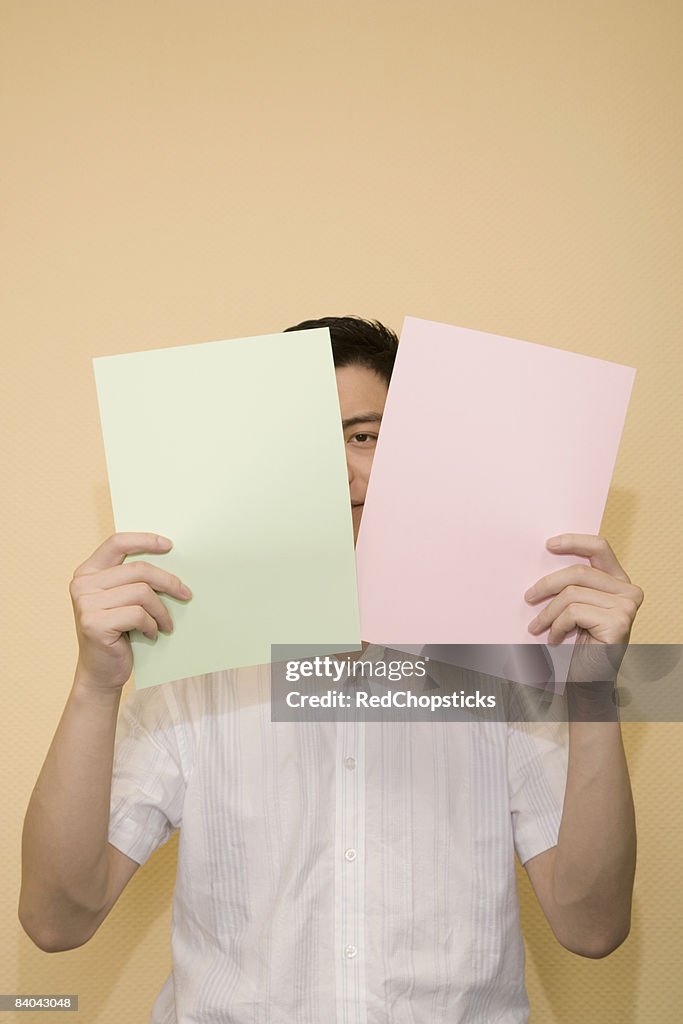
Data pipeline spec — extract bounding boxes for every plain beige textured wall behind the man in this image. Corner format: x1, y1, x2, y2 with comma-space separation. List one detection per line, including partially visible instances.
0, 0, 683, 1024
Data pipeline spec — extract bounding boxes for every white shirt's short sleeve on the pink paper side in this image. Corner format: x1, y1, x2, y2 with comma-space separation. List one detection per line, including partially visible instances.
508, 721, 569, 864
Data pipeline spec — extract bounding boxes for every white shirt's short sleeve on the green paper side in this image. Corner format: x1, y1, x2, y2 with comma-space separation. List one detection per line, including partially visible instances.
109, 685, 185, 864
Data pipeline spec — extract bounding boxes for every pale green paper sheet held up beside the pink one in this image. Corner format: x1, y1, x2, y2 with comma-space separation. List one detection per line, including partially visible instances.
93, 328, 360, 689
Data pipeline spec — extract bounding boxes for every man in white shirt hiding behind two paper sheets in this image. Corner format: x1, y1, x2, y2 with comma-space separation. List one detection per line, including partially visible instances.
19, 317, 643, 1024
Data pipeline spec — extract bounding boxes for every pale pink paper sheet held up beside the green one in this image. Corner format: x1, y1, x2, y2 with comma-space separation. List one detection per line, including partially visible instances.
356, 316, 636, 682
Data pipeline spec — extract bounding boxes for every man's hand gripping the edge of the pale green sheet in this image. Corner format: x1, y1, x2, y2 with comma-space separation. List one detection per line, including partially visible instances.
69, 534, 191, 690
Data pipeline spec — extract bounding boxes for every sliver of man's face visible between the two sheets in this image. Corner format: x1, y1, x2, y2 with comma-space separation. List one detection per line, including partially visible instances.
335, 365, 388, 543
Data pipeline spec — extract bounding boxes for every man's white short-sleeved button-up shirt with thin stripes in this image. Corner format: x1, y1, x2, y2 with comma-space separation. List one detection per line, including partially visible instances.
109, 647, 568, 1024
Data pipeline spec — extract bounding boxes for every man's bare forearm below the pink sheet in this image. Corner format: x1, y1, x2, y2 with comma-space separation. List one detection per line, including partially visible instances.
553, 721, 636, 948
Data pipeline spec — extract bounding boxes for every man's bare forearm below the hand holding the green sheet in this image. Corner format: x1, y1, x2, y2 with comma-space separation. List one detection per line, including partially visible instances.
19, 670, 121, 944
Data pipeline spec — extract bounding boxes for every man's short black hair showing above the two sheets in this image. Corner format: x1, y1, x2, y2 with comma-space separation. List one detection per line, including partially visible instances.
285, 316, 398, 386
